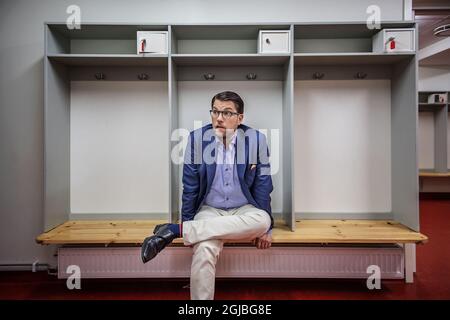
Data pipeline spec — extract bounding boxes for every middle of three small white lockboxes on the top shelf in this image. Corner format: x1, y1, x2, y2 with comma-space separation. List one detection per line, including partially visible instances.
258, 30, 291, 53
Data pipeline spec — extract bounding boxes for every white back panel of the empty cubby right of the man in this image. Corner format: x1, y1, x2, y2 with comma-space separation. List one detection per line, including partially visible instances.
294, 80, 391, 213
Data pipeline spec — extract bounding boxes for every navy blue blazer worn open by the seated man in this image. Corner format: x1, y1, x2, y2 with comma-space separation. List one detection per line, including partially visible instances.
182, 124, 273, 229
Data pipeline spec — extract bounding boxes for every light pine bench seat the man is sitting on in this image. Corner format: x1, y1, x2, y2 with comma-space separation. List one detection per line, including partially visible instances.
36, 220, 428, 245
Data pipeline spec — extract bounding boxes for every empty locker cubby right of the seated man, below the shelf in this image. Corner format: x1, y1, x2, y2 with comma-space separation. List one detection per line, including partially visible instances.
293, 45, 419, 228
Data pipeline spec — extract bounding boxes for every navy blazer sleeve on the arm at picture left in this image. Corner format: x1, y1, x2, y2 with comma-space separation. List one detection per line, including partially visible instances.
181, 134, 200, 221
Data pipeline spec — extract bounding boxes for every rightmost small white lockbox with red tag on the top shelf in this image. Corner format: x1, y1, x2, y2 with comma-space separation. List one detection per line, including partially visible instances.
372, 28, 416, 53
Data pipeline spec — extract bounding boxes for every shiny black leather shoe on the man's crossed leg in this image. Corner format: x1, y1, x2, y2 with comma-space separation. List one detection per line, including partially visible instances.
141, 223, 176, 263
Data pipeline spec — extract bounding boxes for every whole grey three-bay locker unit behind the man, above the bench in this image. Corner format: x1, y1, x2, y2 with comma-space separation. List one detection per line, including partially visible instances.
44, 22, 419, 231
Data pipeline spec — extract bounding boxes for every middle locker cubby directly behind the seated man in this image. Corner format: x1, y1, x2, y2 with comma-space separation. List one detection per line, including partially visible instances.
171, 48, 293, 225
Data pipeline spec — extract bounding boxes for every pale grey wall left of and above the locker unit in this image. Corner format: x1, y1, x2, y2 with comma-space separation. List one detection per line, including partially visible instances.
0, 0, 403, 264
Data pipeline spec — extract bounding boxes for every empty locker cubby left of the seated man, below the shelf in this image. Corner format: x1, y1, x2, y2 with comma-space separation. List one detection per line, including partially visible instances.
44, 25, 170, 228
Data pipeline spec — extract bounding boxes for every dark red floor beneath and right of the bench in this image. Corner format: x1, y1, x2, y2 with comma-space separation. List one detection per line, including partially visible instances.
0, 199, 450, 300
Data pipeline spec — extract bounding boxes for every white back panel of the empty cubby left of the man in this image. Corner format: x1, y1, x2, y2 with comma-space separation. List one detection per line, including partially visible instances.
70, 81, 169, 213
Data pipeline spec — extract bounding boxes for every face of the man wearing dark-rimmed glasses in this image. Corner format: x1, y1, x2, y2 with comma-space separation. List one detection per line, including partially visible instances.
211, 99, 244, 137
